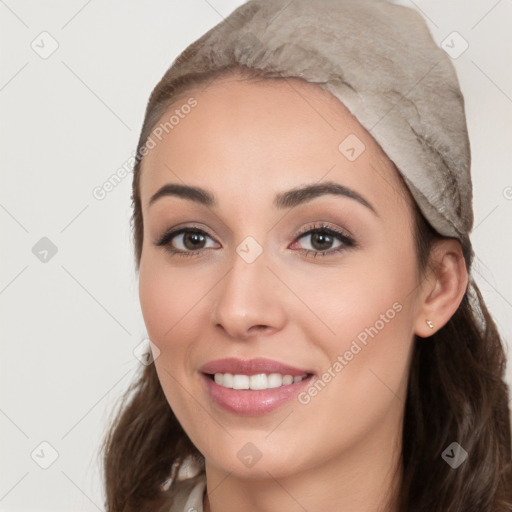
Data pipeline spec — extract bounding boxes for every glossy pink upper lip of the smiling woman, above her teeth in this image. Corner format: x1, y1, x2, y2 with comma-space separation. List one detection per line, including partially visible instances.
200, 357, 313, 377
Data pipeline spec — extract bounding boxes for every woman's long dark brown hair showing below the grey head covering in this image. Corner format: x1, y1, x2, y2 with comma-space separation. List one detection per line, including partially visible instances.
101, 65, 512, 512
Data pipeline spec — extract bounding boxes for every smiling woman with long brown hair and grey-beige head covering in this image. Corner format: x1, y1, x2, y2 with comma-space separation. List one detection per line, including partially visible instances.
100, 0, 512, 512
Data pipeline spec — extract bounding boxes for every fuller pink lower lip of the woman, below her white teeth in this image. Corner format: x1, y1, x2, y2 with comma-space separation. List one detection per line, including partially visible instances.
202, 373, 313, 416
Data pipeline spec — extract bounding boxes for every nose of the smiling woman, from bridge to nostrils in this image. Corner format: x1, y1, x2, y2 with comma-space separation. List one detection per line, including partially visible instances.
212, 247, 286, 341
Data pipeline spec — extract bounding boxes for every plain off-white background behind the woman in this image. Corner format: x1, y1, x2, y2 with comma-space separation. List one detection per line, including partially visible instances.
0, 0, 512, 512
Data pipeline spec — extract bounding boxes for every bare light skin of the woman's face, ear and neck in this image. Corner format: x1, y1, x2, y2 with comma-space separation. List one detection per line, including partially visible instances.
139, 75, 467, 512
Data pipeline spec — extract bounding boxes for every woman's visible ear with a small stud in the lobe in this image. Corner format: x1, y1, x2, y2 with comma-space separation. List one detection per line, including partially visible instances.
414, 238, 469, 338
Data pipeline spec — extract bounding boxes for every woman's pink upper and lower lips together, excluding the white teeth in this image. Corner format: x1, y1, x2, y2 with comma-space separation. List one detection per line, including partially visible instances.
200, 358, 312, 416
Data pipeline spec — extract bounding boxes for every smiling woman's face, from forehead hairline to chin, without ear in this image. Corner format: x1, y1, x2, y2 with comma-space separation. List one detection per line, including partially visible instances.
139, 76, 426, 478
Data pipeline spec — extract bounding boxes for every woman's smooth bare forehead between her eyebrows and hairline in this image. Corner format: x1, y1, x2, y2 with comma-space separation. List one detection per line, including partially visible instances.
140, 75, 407, 210
